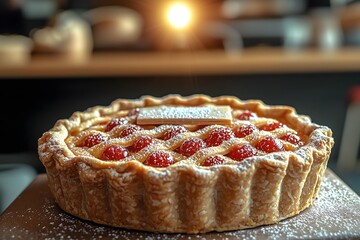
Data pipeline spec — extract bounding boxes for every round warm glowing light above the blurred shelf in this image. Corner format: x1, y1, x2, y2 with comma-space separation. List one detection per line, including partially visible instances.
167, 3, 191, 28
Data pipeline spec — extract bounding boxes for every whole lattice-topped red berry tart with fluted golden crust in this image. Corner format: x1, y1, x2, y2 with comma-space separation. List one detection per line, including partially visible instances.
38, 95, 334, 233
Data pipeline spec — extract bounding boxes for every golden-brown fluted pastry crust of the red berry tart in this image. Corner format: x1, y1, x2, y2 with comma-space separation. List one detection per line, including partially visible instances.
38, 95, 333, 233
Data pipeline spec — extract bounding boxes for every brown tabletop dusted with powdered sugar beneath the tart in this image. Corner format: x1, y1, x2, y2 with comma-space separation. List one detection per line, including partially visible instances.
0, 170, 360, 240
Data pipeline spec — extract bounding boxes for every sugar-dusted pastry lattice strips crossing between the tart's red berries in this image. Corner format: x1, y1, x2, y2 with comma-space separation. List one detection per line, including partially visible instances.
67, 111, 297, 167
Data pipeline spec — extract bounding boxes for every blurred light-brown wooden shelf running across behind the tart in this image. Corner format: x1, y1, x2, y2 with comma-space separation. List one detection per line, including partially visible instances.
0, 47, 360, 78
